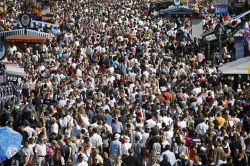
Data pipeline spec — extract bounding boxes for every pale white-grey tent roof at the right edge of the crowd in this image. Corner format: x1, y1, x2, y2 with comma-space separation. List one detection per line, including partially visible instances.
219, 57, 250, 74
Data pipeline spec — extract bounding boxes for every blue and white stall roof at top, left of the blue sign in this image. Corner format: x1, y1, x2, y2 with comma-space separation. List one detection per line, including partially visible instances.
161, 6, 193, 15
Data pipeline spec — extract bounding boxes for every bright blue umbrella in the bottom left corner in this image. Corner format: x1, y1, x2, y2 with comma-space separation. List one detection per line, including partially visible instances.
0, 126, 23, 161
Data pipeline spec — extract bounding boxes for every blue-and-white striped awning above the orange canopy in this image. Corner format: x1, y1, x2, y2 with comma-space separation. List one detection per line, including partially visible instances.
0, 29, 51, 38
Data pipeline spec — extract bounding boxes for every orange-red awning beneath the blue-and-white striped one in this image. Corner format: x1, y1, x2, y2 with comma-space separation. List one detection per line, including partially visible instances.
6, 35, 46, 43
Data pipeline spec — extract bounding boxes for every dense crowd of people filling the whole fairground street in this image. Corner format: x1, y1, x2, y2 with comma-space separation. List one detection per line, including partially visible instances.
0, 0, 250, 166
